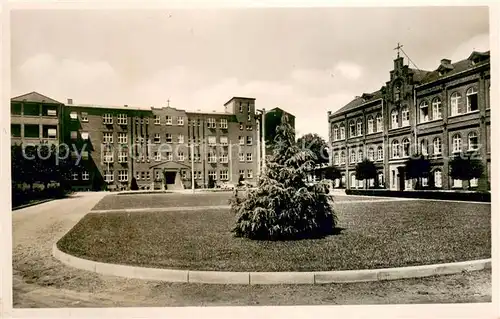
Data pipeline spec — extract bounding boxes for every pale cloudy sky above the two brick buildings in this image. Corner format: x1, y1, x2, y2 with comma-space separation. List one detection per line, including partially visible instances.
11, 7, 489, 139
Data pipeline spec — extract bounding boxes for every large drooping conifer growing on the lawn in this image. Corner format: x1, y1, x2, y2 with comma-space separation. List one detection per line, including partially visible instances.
231, 116, 337, 240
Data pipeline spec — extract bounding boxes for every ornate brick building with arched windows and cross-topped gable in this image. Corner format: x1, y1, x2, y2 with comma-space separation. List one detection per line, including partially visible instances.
328, 51, 491, 190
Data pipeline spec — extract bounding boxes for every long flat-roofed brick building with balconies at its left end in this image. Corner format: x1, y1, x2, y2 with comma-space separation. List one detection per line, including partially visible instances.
11, 92, 259, 190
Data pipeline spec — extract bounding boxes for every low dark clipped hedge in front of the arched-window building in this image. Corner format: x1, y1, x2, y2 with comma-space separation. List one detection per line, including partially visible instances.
345, 189, 491, 202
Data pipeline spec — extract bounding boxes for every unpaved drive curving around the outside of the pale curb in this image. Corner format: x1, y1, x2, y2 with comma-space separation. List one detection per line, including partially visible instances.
12, 193, 491, 308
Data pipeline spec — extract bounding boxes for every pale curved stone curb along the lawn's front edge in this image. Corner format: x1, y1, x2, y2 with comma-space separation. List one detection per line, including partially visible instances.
52, 243, 491, 285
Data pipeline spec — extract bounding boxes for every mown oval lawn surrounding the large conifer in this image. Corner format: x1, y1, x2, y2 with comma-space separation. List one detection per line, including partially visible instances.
58, 200, 491, 271
